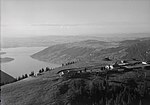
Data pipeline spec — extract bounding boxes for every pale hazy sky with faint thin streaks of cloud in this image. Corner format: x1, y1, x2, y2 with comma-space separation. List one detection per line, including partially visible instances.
1, 0, 150, 37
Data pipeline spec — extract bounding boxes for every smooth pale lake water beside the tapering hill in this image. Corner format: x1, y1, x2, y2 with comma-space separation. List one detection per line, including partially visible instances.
1, 47, 60, 77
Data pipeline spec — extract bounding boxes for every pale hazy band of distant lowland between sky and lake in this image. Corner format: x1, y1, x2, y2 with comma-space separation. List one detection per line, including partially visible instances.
1, 33, 150, 48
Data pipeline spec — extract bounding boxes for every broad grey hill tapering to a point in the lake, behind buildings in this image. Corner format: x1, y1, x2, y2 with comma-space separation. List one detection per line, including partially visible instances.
31, 38, 150, 64
